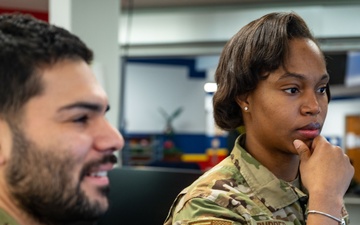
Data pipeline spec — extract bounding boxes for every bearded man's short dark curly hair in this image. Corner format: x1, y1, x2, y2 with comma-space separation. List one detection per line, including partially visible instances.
0, 14, 93, 119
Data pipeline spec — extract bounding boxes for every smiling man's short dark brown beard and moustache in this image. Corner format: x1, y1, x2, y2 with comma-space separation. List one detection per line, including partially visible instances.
5, 125, 111, 224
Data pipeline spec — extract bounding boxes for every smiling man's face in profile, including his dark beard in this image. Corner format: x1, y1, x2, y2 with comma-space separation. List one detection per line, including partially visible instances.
5, 60, 124, 224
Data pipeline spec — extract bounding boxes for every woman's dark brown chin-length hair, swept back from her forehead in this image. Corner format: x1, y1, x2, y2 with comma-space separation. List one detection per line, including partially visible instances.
213, 13, 330, 130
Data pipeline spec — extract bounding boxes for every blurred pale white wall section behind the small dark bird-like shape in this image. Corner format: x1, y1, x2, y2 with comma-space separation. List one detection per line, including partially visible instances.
125, 63, 206, 134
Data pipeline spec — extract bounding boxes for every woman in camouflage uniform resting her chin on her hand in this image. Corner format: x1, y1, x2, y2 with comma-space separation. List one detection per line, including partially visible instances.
165, 13, 354, 225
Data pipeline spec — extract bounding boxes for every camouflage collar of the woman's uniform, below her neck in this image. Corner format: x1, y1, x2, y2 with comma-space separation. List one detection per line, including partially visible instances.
231, 134, 307, 212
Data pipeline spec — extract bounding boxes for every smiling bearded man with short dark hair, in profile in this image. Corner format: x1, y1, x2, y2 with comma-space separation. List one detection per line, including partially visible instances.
0, 14, 124, 225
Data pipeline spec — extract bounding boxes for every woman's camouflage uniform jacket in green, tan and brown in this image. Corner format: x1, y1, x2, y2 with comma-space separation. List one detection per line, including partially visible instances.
164, 135, 348, 225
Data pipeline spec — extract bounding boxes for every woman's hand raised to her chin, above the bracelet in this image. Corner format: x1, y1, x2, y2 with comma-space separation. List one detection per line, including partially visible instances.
293, 136, 354, 216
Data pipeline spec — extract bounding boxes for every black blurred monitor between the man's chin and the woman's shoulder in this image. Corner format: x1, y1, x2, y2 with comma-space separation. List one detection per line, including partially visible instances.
97, 167, 202, 225
